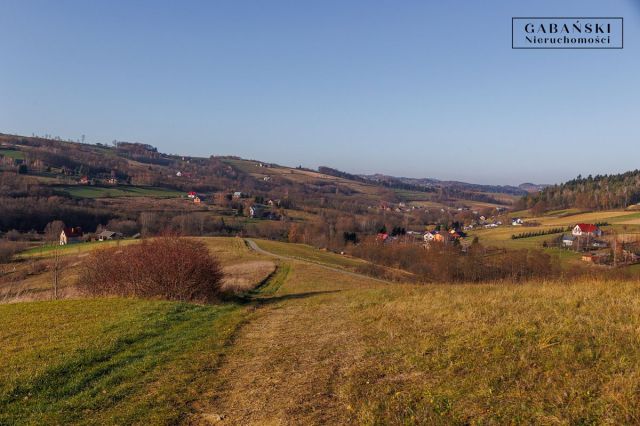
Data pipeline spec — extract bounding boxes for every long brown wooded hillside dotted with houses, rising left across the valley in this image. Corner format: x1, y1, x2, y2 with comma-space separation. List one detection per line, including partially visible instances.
0, 135, 518, 249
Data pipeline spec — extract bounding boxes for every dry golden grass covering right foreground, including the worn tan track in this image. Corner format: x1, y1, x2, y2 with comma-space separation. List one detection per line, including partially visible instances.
195, 248, 640, 424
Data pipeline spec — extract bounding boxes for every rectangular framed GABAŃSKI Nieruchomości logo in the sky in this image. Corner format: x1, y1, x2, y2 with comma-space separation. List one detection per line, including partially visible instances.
511, 18, 624, 49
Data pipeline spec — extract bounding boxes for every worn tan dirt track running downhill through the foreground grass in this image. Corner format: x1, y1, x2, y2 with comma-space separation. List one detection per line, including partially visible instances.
196, 258, 376, 425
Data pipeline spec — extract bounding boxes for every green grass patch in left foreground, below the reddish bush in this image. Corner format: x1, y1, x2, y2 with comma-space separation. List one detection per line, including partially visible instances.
0, 299, 247, 424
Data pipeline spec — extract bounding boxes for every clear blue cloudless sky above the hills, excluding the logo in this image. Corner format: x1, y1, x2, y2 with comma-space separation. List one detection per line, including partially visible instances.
0, 0, 640, 184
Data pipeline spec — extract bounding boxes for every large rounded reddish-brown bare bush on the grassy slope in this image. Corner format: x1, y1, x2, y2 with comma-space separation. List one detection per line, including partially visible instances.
79, 237, 223, 303
